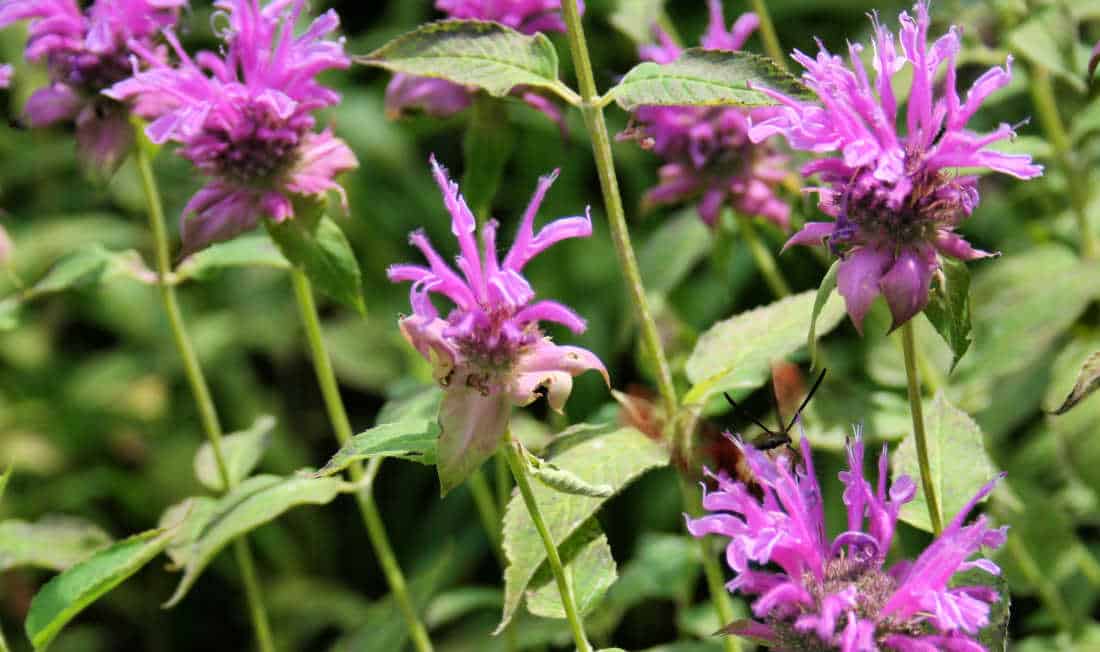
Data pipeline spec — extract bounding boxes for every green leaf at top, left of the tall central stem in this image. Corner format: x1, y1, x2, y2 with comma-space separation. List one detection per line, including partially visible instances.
354, 20, 575, 103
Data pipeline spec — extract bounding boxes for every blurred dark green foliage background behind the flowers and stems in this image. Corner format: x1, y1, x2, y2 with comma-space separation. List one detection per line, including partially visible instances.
0, 0, 1100, 652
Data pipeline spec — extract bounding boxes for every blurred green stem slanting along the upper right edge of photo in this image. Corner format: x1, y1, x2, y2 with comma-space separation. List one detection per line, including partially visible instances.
1031, 65, 1100, 261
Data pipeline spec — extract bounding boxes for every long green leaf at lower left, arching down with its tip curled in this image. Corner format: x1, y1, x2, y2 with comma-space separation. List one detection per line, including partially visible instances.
164, 475, 351, 607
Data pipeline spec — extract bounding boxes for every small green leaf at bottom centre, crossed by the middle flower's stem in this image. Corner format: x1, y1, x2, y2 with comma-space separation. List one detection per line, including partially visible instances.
527, 518, 617, 618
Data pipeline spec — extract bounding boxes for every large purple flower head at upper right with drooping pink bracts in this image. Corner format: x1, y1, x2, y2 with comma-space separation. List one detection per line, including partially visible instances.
749, 1, 1043, 329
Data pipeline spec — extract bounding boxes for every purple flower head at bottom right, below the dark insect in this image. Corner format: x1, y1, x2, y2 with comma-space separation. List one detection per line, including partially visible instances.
688, 429, 1007, 652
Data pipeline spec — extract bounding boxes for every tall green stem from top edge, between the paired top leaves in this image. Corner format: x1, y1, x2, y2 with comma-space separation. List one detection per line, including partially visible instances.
561, 0, 679, 421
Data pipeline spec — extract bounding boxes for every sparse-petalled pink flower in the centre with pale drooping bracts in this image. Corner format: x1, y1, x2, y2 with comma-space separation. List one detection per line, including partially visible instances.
388, 158, 608, 491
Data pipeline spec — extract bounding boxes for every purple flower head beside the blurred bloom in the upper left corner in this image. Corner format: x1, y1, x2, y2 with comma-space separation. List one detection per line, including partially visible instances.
107, 0, 358, 252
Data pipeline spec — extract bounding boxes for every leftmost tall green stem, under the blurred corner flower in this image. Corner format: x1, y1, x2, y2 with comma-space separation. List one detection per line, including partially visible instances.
134, 131, 275, 652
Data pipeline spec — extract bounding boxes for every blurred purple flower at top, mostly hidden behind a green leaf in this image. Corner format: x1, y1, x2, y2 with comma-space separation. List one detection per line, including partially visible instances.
386, 0, 584, 122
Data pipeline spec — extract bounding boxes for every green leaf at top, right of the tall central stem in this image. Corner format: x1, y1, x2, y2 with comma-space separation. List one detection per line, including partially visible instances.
604, 47, 814, 111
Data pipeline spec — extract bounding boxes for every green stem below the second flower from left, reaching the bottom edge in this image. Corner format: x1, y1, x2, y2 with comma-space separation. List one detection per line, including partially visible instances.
290, 267, 432, 652
